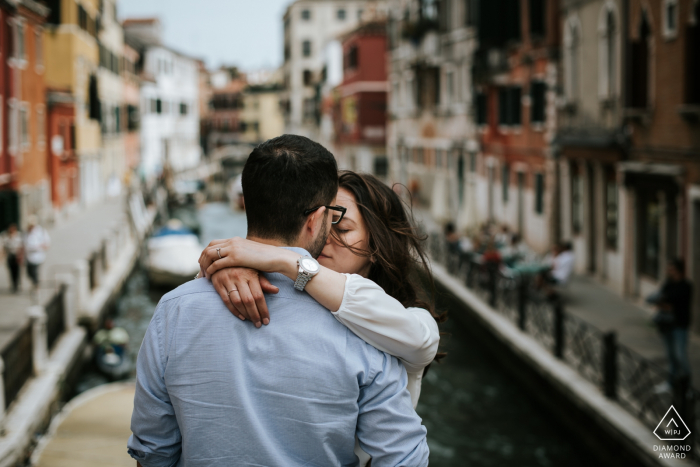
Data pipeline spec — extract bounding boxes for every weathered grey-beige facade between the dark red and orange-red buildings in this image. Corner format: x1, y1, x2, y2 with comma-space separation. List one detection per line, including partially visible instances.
387, 0, 478, 228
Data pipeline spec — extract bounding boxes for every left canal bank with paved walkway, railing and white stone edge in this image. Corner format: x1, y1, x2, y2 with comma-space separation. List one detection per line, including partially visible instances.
0, 194, 156, 466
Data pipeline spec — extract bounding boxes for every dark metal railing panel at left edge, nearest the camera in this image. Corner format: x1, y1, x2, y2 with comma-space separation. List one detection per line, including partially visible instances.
2, 322, 34, 408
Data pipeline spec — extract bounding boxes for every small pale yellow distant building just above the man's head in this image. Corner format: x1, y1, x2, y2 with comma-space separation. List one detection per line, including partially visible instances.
240, 84, 284, 143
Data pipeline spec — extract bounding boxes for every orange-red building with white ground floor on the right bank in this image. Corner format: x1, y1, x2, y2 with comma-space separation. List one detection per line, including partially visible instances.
474, 0, 561, 251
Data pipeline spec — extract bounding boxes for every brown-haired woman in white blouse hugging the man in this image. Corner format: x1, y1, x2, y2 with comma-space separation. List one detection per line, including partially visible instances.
200, 172, 443, 458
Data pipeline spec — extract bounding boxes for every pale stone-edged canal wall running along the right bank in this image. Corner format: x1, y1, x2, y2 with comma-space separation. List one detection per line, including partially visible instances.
433, 262, 697, 467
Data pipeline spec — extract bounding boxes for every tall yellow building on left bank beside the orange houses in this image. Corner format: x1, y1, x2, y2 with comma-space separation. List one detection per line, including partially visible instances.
44, 0, 105, 205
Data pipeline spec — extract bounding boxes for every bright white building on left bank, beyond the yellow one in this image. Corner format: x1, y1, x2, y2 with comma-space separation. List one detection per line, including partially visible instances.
124, 19, 201, 181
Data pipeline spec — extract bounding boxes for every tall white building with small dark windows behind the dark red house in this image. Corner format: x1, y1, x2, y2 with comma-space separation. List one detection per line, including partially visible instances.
282, 0, 386, 139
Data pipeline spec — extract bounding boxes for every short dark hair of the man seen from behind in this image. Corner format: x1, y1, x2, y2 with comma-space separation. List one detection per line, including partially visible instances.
242, 135, 338, 243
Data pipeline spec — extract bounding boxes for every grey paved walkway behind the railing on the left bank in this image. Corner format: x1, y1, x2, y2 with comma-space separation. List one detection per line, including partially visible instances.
0, 197, 126, 349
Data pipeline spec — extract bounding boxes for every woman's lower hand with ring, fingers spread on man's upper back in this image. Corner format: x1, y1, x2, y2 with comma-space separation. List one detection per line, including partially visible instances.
211, 266, 279, 328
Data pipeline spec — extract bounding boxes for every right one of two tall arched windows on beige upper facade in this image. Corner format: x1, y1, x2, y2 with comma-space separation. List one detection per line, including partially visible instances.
598, 3, 619, 100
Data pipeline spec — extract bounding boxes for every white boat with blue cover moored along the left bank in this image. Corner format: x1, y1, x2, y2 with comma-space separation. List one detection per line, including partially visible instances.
147, 219, 204, 287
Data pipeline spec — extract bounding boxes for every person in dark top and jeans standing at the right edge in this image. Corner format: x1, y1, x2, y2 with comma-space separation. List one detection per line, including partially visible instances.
655, 258, 693, 387
